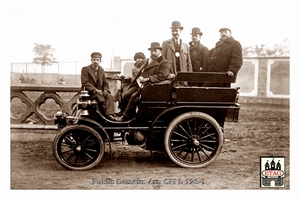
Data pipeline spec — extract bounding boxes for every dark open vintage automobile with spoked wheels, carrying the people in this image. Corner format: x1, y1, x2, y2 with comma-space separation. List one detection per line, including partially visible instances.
53, 72, 240, 170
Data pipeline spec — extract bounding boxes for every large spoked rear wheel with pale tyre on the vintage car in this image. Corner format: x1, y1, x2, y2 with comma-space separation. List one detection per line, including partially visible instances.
164, 112, 223, 168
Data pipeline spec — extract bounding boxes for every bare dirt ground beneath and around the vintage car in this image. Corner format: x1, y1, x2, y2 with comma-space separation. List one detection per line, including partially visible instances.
10, 104, 290, 191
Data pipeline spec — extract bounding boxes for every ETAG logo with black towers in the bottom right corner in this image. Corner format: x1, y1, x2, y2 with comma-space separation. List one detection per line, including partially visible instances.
260, 156, 285, 187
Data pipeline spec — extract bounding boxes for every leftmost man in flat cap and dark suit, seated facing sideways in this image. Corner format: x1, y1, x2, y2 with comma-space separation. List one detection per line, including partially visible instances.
81, 52, 116, 121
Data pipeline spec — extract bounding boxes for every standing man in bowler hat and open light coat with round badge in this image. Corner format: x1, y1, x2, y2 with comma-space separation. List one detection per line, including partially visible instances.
162, 21, 192, 84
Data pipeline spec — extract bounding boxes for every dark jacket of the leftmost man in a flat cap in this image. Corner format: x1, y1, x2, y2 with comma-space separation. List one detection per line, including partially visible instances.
81, 64, 110, 101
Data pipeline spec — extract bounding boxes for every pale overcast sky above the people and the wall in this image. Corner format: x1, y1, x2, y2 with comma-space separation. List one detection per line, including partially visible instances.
10, 0, 292, 65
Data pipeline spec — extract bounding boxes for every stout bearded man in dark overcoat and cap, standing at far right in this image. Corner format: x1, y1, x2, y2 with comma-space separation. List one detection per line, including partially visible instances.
203, 28, 243, 87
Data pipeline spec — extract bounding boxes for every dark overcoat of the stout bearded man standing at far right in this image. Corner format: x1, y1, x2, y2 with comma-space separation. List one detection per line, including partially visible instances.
208, 37, 243, 75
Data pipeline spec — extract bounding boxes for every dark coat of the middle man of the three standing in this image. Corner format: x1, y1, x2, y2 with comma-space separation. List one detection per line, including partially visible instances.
189, 41, 210, 72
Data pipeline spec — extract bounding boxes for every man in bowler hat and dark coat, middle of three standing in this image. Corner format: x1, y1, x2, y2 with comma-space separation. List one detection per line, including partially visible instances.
189, 27, 210, 86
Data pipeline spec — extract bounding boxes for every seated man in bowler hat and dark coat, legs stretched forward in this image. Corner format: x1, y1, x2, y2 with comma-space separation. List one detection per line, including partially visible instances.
118, 42, 171, 121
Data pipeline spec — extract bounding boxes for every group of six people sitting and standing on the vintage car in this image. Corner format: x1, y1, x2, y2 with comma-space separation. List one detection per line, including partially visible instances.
81, 21, 243, 121
